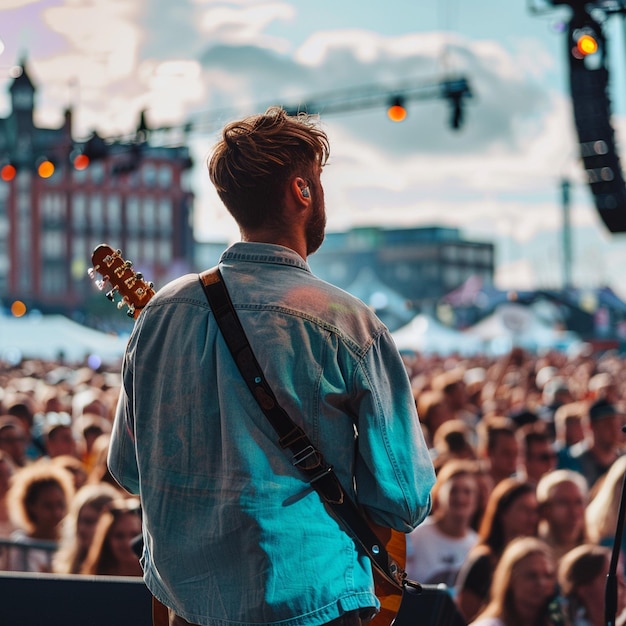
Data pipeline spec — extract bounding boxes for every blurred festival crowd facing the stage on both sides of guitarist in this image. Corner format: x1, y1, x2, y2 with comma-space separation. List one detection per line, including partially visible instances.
0, 342, 626, 626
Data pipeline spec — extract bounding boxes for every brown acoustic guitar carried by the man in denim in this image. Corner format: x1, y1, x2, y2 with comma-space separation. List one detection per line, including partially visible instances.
88, 243, 406, 626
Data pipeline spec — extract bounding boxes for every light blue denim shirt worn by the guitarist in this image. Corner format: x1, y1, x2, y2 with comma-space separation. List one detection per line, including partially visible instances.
109, 243, 434, 626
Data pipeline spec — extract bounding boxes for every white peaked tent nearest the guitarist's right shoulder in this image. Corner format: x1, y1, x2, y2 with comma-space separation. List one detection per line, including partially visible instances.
391, 313, 483, 356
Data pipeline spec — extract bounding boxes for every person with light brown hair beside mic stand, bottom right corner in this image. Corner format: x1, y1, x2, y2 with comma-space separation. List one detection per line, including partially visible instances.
558, 544, 626, 626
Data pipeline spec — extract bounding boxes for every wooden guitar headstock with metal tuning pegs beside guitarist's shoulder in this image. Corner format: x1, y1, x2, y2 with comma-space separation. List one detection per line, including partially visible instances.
88, 243, 155, 319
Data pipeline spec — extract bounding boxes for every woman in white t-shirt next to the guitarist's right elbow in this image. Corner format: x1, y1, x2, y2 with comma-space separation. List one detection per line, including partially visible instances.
406, 460, 478, 589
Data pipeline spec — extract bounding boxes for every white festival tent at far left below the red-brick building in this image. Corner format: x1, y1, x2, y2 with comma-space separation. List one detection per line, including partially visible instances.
0, 313, 128, 363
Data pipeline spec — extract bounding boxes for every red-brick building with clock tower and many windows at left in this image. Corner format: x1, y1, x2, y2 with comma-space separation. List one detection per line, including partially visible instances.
0, 64, 194, 313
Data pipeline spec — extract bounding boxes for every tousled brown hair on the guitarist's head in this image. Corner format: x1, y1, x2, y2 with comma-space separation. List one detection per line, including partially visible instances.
208, 107, 330, 229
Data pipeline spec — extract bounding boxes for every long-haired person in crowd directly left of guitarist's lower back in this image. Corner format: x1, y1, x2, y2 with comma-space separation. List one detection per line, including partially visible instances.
81, 498, 143, 576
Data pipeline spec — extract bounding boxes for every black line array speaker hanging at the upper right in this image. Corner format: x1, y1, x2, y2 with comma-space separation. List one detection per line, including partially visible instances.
567, 11, 626, 233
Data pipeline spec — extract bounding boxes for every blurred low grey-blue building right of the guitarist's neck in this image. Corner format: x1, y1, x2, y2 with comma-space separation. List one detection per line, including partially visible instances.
309, 227, 495, 309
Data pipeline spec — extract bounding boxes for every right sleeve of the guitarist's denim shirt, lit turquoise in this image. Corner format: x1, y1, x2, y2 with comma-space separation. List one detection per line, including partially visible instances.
355, 332, 435, 532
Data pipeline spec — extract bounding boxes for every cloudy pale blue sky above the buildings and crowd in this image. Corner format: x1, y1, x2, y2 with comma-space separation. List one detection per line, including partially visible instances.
0, 0, 626, 297
